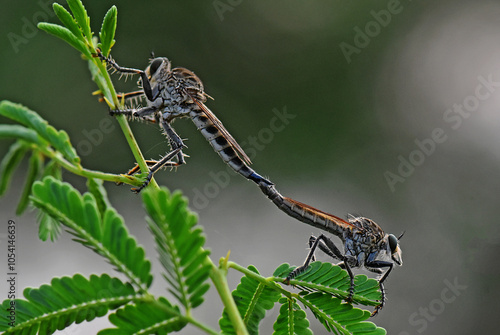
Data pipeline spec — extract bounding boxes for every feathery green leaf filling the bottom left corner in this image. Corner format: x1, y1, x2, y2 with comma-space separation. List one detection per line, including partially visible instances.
0, 274, 137, 334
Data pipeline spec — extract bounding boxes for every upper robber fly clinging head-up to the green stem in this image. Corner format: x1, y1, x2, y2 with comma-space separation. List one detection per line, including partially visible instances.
97, 51, 271, 193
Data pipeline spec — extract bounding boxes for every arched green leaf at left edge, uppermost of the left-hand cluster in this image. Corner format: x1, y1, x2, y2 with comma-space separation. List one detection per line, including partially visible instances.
0, 100, 80, 164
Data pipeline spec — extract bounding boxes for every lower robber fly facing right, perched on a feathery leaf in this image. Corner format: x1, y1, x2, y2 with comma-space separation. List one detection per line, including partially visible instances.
259, 182, 403, 316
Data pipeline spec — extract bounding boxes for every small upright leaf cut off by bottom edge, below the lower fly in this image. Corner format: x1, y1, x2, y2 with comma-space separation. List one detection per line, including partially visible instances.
273, 298, 313, 335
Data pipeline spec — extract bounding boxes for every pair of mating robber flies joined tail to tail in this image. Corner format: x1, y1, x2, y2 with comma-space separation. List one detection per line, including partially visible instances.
98, 52, 403, 316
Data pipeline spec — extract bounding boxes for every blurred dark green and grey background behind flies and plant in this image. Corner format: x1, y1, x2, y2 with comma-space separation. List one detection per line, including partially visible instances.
0, 0, 500, 335
